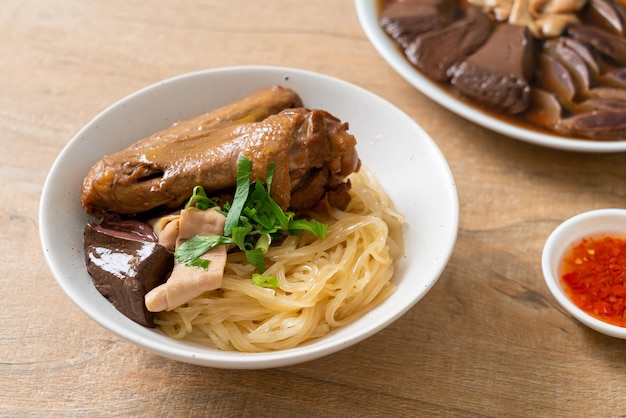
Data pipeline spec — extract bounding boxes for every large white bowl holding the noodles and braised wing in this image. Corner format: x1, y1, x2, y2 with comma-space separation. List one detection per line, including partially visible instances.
39, 67, 459, 369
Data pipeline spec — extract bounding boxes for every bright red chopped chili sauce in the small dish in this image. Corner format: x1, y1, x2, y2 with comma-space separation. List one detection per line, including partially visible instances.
561, 237, 626, 327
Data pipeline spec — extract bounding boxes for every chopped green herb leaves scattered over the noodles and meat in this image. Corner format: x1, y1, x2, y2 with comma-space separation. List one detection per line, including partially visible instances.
174, 156, 327, 287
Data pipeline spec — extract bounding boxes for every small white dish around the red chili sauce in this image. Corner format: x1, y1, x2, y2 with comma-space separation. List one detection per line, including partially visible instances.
541, 209, 626, 339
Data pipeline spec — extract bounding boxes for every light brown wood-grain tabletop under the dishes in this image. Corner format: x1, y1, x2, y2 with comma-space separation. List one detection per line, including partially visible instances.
0, 0, 626, 417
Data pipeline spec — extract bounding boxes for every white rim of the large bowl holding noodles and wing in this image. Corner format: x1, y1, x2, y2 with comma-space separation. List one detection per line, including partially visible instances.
39, 65, 459, 369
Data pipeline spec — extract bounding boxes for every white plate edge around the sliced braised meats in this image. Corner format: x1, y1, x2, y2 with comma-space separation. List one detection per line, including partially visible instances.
354, 0, 626, 152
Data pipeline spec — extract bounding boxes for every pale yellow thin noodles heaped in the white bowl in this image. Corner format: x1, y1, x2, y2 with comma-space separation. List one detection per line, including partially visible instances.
155, 167, 404, 352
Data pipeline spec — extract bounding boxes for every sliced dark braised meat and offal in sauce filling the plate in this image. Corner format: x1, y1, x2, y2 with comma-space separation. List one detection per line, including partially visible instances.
379, 0, 626, 140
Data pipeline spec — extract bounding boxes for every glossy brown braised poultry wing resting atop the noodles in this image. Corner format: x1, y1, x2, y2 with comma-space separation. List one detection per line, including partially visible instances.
81, 88, 360, 216
